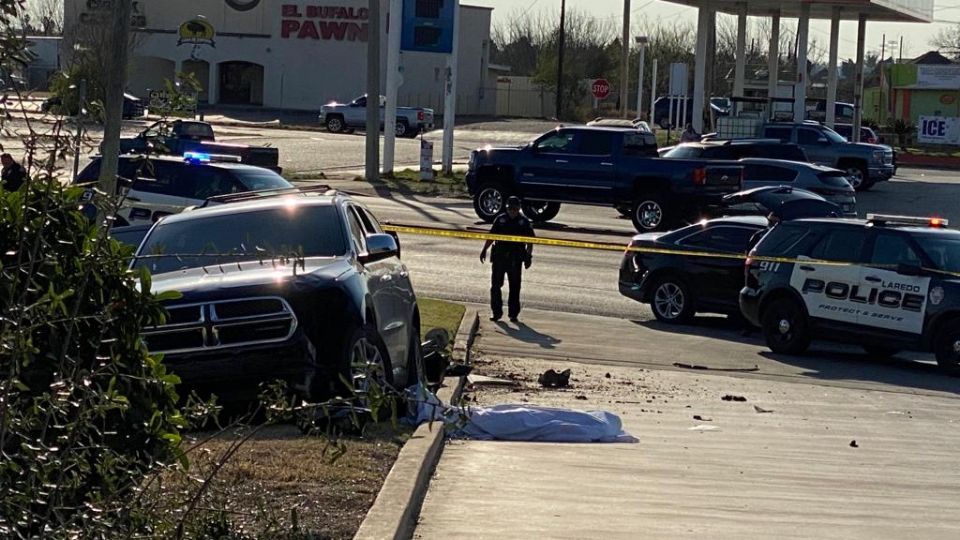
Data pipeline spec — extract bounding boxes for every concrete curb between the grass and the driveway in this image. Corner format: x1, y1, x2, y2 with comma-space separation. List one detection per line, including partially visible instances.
354, 306, 480, 540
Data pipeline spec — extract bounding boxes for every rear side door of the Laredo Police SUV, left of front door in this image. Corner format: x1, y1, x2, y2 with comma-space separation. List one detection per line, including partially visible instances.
790, 225, 869, 326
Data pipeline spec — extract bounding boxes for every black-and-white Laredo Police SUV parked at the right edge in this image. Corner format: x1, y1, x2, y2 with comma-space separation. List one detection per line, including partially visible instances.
740, 214, 960, 373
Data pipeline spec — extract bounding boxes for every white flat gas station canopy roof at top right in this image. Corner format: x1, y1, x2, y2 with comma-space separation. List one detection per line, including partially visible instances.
667, 0, 933, 23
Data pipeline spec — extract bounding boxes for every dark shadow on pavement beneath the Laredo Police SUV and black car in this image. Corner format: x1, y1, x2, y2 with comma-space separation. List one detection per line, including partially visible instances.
633, 317, 960, 395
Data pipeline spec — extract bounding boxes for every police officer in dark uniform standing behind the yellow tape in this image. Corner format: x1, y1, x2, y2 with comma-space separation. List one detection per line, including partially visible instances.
480, 197, 536, 322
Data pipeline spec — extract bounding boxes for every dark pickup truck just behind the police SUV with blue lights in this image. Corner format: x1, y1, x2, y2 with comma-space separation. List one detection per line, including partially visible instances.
114, 120, 281, 173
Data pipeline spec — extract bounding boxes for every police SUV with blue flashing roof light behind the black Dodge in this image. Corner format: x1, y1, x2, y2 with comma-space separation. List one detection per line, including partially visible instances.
76, 152, 293, 226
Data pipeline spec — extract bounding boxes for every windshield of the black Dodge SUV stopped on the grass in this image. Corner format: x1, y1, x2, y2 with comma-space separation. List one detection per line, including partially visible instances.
133, 206, 347, 274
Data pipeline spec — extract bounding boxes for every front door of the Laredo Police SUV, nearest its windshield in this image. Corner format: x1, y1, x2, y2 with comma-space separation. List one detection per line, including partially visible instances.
860, 229, 930, 335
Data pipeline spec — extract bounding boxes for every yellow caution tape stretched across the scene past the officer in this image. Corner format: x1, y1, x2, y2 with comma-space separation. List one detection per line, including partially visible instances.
383, 224, 960, 277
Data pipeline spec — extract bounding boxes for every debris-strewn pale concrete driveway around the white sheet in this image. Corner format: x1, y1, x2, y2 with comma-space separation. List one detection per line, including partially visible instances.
416, 314, 960, 539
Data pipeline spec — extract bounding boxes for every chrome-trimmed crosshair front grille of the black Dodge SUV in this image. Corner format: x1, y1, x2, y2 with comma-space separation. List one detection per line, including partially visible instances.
143, 297, 297, 354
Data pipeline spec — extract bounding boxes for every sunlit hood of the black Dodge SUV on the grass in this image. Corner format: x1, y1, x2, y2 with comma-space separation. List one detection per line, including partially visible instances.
151, 257, 353, 301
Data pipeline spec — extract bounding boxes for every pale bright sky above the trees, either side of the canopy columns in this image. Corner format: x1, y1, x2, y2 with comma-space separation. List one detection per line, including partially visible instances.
461, 0, 960, 58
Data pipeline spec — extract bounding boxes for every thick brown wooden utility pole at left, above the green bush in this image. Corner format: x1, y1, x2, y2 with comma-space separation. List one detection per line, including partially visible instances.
99, 0, 133, 196
